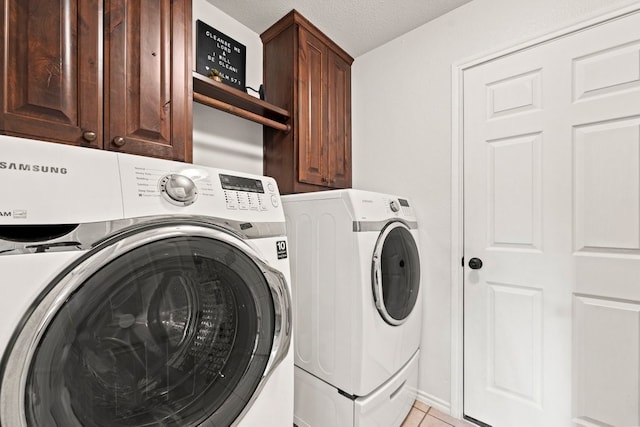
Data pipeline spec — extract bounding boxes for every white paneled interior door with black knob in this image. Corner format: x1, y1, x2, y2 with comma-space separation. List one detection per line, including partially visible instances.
463, 13, 640, 427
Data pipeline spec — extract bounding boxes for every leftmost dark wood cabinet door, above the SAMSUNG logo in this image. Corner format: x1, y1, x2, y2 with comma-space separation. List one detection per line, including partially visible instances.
0, 0, 102, 147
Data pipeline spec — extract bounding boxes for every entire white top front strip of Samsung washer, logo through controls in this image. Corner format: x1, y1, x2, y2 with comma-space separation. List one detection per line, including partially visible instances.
0, 135, 284, 225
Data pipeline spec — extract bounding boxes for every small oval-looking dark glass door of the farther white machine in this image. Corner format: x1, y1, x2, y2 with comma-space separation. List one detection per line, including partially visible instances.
372, 221, 420, 326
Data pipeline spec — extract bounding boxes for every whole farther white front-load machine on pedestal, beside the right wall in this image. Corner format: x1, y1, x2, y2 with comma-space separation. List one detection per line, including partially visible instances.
282, 190, 422, 427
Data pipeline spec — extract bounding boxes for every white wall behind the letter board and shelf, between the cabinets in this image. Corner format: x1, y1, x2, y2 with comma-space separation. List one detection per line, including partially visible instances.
193, 0, 262, 175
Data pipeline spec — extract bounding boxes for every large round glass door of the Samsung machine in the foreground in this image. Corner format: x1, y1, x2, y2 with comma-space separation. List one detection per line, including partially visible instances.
0, 222, 290, 426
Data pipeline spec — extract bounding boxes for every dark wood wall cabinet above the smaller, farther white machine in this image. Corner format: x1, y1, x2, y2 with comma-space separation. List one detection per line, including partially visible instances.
261, 11, 353, 193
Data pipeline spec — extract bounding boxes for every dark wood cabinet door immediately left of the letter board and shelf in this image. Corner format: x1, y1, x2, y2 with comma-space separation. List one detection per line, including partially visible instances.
105, 0, 192, 161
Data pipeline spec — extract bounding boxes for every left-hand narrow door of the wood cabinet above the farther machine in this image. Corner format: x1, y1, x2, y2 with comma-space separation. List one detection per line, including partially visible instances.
296, 29, 328, 185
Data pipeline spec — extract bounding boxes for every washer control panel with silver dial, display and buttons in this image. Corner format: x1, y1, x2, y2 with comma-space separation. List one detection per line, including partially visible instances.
117, 153, 284, 223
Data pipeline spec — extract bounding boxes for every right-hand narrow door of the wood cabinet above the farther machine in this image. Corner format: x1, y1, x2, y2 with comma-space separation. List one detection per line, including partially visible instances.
327, 52, 351, 188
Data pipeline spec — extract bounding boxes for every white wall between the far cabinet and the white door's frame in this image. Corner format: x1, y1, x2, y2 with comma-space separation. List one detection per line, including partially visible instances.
352, 0, 637, 411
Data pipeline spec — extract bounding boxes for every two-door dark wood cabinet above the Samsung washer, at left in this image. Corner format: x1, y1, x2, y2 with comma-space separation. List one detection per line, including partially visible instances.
0, 0, 192, 161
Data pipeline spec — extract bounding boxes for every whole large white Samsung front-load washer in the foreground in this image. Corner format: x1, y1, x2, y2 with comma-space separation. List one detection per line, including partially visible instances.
0, 136, 294, 427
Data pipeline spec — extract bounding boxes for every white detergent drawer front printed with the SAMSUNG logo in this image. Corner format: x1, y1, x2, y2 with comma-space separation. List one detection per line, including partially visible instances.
0, 136, 122, 225
